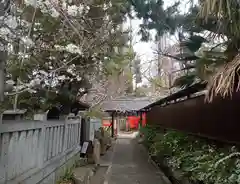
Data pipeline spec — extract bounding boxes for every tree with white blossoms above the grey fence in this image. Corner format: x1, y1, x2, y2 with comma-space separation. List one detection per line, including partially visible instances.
0, 0, 132, 112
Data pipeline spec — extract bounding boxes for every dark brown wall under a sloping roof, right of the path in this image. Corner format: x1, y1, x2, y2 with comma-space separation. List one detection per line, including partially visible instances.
146, 93, 240, 144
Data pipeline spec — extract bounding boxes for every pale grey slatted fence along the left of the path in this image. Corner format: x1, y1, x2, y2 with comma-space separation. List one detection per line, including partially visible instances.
0, 117, 81, 184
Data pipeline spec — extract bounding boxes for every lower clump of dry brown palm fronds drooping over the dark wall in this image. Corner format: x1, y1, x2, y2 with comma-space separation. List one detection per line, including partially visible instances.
205, 54, 240, 102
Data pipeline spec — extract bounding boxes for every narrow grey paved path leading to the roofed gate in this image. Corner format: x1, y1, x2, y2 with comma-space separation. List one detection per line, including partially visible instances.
107, 133, 169, 184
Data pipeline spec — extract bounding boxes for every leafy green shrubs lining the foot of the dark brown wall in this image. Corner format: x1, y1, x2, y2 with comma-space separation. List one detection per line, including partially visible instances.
141, 127, 240, 184
